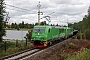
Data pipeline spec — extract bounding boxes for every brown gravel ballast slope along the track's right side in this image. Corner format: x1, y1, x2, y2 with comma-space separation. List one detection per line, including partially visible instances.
20, 38, 72, 60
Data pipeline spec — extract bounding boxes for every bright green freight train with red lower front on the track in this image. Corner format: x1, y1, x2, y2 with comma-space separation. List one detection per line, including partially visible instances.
31, 26, 78, 48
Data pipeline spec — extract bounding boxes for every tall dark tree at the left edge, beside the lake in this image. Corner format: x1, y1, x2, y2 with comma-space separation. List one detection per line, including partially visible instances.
0, 0, 5, 42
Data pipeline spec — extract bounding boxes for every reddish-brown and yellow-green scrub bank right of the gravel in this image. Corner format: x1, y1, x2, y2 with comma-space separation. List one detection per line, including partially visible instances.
54, 40, 90, 60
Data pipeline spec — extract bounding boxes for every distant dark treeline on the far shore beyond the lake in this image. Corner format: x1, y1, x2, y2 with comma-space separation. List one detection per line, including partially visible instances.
3, 21, 48, 29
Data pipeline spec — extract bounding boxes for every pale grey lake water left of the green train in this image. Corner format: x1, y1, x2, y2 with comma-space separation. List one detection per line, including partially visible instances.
3, 30, 28, 40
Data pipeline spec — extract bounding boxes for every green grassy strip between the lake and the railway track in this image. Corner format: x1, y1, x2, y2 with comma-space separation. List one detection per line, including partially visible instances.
0, 41, 31, 57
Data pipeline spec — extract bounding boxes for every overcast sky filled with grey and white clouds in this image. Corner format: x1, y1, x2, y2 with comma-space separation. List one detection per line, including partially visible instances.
5, 0, 90, 25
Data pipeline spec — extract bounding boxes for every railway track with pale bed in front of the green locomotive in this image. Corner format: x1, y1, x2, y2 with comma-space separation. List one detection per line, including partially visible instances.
0, 38, 71, 60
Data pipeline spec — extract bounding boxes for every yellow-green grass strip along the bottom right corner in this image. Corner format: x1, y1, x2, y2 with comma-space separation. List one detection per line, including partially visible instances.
51, 49, 90, 60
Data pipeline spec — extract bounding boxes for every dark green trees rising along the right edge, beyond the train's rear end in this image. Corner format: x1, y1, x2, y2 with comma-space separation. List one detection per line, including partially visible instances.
69, 7, 90, 39
